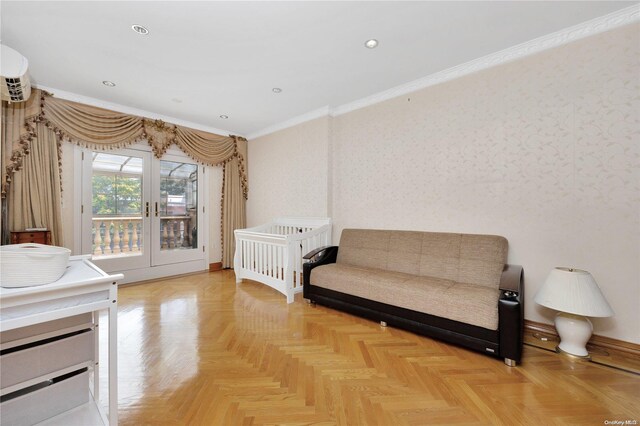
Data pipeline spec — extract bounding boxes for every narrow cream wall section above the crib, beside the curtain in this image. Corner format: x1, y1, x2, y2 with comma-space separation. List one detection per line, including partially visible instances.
247, 113, 330, 227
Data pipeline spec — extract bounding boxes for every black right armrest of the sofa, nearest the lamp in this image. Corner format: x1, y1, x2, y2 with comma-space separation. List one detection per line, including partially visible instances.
498, 265, 524, 363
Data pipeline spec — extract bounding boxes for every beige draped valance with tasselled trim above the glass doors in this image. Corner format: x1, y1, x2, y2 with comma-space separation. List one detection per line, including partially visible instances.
2, 90, 248, 199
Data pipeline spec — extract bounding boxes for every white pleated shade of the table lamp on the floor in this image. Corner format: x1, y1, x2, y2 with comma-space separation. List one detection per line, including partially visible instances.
534, 267, 614, 317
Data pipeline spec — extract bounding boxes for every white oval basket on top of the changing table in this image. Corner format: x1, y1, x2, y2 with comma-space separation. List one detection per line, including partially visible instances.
0, 243, 71, 287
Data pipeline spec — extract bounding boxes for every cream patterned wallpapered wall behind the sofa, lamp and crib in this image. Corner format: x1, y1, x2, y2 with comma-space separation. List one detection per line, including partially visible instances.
248, 24, 640, 343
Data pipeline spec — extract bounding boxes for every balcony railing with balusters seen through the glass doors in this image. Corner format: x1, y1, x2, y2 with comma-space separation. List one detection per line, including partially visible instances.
91, 216, 194, 258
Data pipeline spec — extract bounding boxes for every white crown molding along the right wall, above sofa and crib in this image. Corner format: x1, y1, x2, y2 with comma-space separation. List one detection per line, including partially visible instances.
248, 4, 640, 139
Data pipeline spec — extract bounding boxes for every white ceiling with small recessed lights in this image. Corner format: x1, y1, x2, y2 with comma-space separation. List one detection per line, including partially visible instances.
0, 0, 638, 135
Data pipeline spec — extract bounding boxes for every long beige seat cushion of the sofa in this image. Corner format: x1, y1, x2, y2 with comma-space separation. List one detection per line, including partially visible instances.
310, 263, 500, 330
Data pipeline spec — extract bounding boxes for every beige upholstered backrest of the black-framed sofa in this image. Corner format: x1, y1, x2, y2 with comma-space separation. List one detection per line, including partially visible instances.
337, 229, 508, 288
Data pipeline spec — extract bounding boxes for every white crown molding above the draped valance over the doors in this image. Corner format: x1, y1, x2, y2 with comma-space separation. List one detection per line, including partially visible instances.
34, 84, 235, 136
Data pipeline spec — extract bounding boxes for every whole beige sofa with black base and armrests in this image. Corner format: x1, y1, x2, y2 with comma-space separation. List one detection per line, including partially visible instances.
304, 229, 524, 365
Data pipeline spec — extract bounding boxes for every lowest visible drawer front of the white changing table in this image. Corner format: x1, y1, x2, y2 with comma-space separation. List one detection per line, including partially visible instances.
0, 371, 90, 426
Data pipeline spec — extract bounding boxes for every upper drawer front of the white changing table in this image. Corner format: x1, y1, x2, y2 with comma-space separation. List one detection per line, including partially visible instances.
0, 330, 95, 389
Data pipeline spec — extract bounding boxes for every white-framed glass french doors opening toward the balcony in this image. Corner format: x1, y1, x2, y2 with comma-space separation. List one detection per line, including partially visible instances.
82, 149, 204, 273
